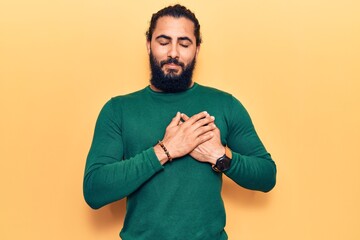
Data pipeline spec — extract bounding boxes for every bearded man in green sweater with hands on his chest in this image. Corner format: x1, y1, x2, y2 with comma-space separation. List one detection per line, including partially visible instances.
84, 5, 276, 240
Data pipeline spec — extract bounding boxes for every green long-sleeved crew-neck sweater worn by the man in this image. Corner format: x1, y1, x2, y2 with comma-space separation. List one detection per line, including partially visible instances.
84, 83, 276, 240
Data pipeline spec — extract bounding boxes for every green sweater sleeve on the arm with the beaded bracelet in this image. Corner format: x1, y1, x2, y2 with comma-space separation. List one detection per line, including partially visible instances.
83, 100, 163, 209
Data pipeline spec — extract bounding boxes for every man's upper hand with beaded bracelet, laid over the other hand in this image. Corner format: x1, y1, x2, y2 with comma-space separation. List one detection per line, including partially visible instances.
155, 112, 216, 164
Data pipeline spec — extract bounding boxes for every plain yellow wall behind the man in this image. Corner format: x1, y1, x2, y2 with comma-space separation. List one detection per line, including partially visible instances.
0, 0, 360, 240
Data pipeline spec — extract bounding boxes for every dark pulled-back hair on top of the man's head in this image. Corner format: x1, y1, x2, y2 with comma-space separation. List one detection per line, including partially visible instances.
146, 4, 201, 46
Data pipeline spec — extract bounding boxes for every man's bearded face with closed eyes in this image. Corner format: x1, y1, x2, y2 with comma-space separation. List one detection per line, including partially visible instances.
147, 16, 199, 92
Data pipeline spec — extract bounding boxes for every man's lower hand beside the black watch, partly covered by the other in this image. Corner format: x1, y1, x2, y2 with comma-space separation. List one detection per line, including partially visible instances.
181, 114, 225, 164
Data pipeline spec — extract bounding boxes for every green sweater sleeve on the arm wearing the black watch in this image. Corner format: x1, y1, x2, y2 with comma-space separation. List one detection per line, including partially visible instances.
225, 98, 276, 192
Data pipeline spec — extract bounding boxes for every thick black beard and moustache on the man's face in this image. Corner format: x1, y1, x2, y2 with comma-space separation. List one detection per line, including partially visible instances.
150, 52, 196, 93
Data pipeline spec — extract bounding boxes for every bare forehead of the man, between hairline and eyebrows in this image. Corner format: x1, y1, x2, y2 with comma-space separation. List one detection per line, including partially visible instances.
153, 16, 195, 40
